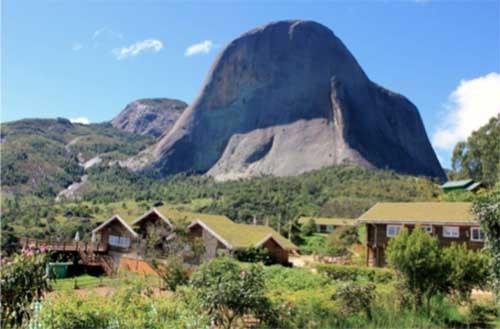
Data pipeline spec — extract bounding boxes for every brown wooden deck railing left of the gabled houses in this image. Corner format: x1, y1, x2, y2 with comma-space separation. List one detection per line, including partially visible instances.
19, 238, 108, 253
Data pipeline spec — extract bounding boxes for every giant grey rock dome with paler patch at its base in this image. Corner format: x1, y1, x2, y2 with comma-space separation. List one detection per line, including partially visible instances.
127, 21, 444, 179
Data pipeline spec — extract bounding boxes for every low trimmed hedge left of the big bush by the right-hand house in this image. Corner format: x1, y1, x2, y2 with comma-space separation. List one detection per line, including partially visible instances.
316, 264, 395, 283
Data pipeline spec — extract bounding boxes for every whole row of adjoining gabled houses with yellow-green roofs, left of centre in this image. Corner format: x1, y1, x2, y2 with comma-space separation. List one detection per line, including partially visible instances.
92, 206, 297, 264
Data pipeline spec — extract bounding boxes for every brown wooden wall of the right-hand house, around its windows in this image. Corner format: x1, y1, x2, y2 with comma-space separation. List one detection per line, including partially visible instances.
366, 224, 484, 266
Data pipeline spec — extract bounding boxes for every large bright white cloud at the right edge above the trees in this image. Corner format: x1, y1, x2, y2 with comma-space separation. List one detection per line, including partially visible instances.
432, 73, 500, 150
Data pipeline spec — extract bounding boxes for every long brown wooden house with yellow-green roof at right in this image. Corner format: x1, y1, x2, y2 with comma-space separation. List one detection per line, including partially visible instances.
358, 202, 484, 266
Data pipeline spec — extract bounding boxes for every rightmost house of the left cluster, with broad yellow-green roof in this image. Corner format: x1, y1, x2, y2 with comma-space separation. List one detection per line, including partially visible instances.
188, 216, 298, 265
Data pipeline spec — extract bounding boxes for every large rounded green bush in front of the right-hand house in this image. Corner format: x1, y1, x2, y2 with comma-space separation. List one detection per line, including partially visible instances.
386, 227, 488, 308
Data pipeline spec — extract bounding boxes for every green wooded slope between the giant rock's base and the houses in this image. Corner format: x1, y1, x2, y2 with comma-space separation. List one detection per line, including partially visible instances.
3, 166, 440, 249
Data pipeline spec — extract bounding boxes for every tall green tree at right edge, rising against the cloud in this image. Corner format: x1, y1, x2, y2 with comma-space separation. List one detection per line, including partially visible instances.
449, 115, 500, 186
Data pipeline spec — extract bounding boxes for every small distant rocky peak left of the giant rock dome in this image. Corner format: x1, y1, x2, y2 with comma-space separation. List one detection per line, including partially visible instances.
111, 98, 187, 137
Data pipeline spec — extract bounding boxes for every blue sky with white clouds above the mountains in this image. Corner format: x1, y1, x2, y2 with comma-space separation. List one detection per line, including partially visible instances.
1, 0, 500, 167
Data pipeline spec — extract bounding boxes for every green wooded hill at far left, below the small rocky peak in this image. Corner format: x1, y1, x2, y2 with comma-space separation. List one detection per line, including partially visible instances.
0, 119, 152, 198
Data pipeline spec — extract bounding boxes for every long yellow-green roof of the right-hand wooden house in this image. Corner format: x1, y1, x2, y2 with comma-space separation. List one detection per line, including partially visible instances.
359, 202, 477, 224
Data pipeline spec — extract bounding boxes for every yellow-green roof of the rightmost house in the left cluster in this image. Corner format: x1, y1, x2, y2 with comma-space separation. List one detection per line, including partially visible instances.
194, 216, 298, 250
